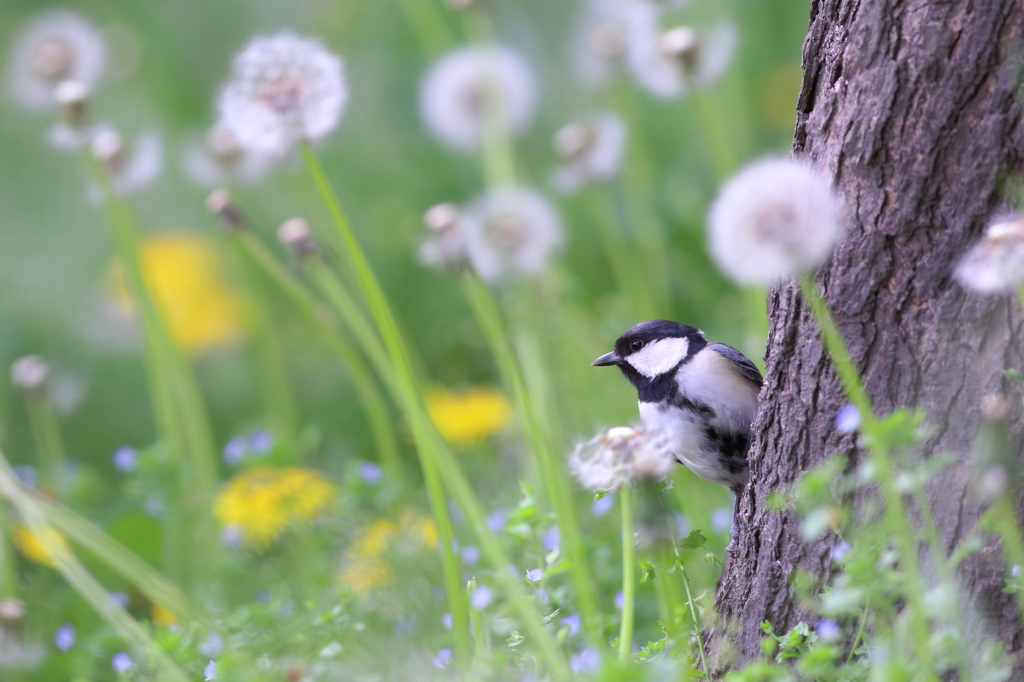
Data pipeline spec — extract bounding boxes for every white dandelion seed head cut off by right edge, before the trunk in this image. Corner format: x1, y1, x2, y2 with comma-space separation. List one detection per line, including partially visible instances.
954, 214, 1024, 294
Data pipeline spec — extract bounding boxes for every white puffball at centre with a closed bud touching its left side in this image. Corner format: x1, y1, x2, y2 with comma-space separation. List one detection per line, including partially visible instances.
459, 187, 564, 283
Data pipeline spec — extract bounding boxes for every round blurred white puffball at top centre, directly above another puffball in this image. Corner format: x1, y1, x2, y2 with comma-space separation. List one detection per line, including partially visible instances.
420, 46, 538, 152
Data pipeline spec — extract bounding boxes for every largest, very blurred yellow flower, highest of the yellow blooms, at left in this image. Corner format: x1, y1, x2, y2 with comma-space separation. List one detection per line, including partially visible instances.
111, 232, 245, 354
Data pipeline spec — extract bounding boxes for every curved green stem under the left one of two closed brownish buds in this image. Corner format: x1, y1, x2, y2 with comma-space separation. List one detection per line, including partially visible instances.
232, 231, 403, 481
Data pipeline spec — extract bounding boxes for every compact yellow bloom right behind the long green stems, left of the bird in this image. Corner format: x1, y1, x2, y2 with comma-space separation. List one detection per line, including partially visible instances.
426, 388, 512, 445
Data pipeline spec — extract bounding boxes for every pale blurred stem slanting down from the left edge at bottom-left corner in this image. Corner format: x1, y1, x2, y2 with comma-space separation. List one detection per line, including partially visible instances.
0, 444, 188, 682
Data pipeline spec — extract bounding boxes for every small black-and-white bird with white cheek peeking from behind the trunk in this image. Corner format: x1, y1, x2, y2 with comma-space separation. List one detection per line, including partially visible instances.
592, 319, 762, 552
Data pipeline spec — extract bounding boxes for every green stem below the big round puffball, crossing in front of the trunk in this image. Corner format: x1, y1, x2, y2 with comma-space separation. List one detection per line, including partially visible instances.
800, 275, 935, 679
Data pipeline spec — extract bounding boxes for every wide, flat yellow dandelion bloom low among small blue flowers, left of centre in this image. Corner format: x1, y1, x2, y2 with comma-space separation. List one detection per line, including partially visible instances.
214, 467, 335, 549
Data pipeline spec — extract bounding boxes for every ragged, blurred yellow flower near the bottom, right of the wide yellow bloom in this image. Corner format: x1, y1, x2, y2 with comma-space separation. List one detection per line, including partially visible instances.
339, 510, 437, 597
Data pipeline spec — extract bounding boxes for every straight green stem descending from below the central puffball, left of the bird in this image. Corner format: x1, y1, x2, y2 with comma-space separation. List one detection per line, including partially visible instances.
463, 272, 600, 640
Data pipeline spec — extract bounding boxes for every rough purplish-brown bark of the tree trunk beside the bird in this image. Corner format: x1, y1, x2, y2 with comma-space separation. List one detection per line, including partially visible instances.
712, 0, 1024, 672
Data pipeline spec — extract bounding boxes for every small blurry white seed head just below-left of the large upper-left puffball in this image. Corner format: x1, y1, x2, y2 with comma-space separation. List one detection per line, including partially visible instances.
181, 123, 273, 187
